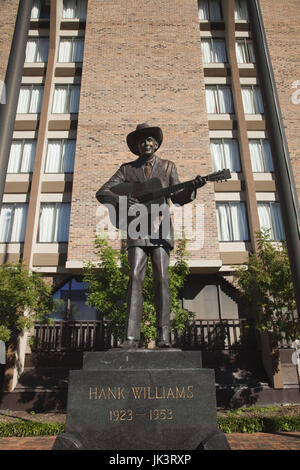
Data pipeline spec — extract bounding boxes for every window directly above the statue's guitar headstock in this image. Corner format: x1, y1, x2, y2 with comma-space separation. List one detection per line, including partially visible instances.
210, 139, 241, 171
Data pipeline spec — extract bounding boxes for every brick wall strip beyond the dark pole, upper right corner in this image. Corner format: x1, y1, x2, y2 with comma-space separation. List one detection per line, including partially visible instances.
260, 0, 300, 197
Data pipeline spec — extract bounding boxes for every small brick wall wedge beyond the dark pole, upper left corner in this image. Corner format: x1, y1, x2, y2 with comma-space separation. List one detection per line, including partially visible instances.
0, 0, 19, 81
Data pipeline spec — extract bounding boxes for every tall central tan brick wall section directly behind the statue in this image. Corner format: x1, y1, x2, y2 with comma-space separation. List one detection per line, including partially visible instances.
68, 0, 219, 261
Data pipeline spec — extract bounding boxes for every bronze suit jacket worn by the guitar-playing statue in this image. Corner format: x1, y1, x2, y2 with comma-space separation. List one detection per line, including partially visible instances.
96, 154, 196, 249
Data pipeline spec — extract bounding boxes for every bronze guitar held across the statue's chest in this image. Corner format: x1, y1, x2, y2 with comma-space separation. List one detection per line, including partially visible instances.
109, 169, 231, 230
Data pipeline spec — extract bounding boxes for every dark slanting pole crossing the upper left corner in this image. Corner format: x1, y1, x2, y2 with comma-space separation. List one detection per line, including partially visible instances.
0, 0, 33, 208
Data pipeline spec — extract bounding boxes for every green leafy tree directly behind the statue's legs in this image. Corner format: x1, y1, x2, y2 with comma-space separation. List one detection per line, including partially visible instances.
83, 236, 193, 345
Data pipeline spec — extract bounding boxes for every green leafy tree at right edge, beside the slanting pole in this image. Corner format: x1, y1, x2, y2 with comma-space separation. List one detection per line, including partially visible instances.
235, 230, 300, 345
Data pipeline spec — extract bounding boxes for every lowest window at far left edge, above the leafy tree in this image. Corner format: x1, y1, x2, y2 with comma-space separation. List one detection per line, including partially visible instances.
0, 203, 28, 243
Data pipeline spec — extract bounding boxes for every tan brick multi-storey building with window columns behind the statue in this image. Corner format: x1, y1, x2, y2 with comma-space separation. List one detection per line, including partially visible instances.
0, 0, 300, 406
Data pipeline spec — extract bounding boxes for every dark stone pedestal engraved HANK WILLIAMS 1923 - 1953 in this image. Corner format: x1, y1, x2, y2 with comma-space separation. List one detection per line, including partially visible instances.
53, 349, 230, 450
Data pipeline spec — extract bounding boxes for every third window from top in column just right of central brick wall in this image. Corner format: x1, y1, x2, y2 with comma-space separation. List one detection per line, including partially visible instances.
205, 85, 234, 114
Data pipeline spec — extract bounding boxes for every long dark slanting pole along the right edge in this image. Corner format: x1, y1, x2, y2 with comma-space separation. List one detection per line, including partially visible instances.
247, 0, 300, 322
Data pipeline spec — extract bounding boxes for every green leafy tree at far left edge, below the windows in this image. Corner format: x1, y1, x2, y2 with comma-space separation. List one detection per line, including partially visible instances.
0, 262, 53, 342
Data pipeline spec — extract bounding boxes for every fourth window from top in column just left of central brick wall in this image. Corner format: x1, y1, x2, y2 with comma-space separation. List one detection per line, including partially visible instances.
45, 139, 76, 173
